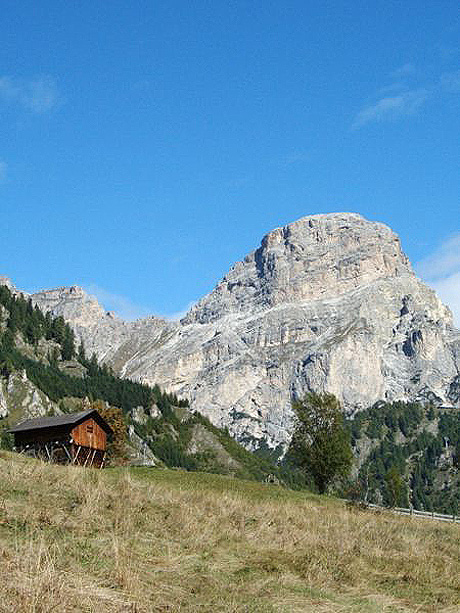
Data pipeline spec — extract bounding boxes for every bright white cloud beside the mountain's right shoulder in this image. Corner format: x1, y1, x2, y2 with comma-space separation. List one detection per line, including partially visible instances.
415, 232, 460, 328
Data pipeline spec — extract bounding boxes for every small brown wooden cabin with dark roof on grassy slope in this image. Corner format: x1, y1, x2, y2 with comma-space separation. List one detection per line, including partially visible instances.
9, 409, 113, 468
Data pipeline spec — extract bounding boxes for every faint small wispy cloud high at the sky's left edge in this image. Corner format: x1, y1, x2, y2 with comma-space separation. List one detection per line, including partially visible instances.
0, 75, 59, 114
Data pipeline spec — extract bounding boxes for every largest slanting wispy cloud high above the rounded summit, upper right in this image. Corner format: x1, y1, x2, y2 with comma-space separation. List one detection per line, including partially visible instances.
353, 88, 429, 128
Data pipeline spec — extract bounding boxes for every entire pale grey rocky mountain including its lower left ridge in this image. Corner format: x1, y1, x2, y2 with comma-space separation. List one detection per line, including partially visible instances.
27, 213, 460, 447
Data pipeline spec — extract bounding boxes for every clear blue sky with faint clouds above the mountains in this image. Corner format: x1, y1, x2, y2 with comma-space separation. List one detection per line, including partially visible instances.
0, 0, 460, 325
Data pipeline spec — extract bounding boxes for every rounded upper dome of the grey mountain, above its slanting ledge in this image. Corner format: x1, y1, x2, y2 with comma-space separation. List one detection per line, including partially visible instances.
184, 213, 413, 323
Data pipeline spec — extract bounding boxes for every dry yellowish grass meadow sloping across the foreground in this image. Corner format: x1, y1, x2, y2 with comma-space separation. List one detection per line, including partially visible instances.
0, 452, 460, 613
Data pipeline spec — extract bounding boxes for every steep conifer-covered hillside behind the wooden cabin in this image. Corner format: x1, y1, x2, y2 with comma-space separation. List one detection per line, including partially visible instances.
0, 285, 277, 480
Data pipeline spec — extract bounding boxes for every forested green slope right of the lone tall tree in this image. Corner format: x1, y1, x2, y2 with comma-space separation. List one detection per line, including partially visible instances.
349, 402, 460, 514
